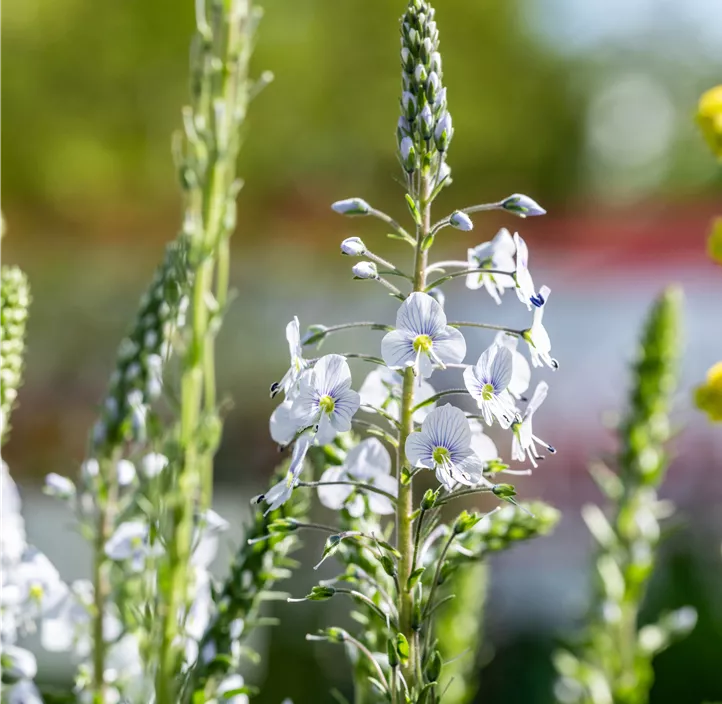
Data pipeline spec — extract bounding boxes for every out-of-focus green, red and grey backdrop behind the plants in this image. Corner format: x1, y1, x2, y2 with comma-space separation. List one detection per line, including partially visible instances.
0, 0, 722, 704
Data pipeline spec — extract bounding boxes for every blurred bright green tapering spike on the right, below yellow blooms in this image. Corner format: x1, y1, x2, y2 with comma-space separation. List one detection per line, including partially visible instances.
555, 288, 696, 704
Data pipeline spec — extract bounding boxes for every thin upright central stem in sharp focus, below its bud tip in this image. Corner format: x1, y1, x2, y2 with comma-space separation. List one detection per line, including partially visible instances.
396, 173, 432, 688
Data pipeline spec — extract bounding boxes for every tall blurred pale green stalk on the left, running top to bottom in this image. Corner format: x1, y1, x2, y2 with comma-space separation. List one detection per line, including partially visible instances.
156, 0, 258, 704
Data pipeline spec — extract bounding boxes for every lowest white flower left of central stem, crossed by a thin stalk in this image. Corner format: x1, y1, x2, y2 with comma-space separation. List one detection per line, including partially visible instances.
318, 438, 397, 518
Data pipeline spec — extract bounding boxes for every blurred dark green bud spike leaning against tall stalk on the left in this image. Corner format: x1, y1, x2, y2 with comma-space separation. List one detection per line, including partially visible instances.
92, 243, 188, 450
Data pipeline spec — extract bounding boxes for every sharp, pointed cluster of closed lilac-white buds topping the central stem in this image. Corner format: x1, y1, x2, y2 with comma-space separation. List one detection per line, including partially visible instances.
396, 0, 454, 173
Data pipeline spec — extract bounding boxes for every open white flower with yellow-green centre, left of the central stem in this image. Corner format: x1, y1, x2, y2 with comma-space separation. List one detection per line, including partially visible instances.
291, 354, 360, 445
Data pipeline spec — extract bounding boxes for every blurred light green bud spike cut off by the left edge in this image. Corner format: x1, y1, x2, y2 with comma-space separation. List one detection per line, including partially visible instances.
0, 266, 30, 445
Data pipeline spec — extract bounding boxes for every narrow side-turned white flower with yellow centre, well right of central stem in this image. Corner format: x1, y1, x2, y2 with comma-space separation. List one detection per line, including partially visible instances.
464, 344, 516, 428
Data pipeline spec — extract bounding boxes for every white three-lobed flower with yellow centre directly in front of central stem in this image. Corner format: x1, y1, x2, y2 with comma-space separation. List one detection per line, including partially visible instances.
381, 293, 466, 379
